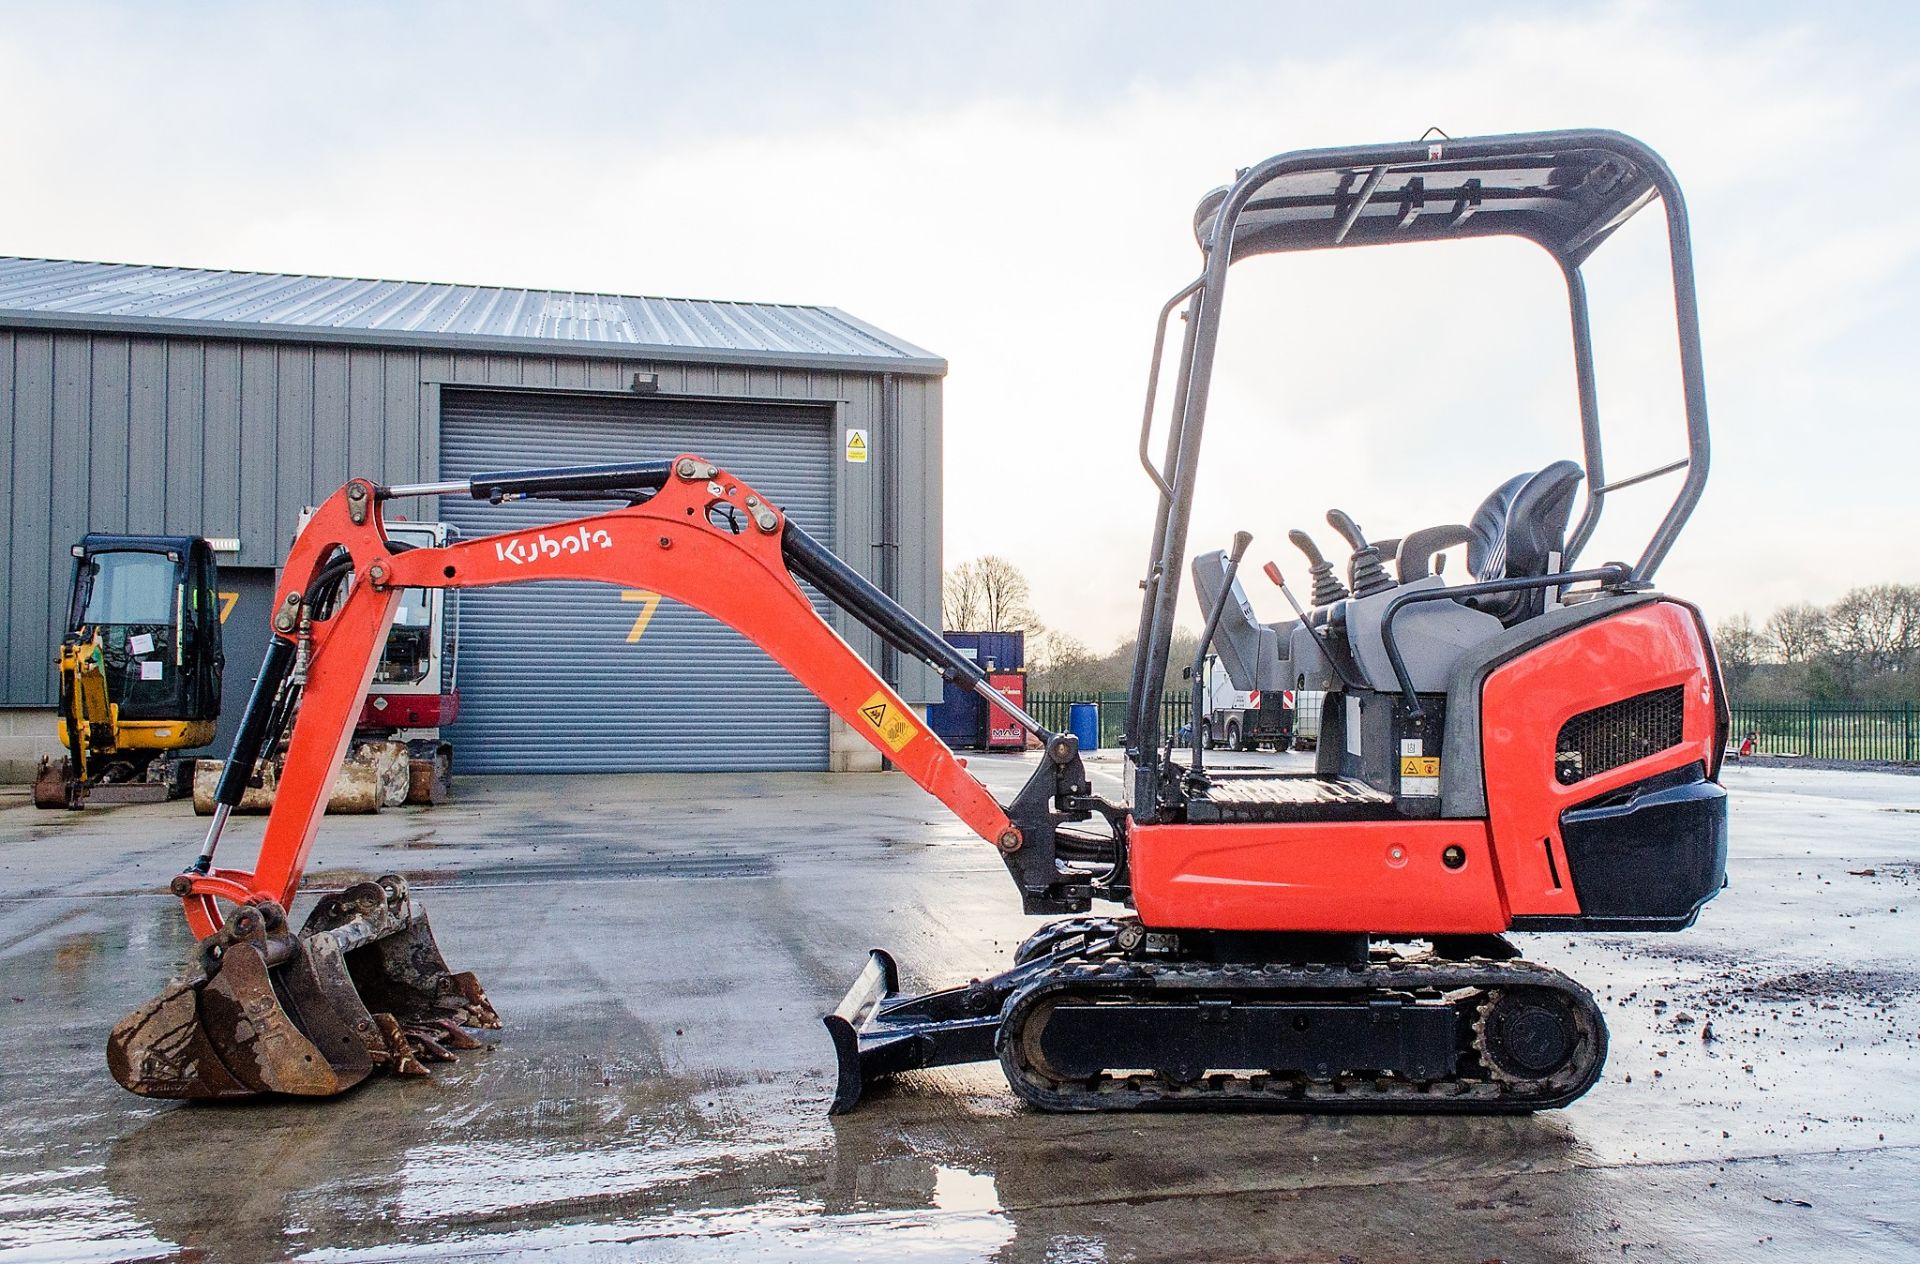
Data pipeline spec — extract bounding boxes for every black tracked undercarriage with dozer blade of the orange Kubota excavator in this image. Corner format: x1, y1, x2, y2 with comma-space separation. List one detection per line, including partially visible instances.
828, 918, 1607, 1114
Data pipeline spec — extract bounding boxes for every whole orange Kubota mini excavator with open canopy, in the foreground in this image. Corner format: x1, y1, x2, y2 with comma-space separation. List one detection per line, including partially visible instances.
108, 131, 1728, 1112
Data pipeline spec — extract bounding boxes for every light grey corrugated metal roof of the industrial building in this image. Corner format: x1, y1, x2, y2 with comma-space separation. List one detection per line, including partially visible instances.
0, 255, 947, 373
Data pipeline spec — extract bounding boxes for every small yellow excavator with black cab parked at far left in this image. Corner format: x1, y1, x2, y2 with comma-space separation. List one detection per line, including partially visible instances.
33, 534, 227, 807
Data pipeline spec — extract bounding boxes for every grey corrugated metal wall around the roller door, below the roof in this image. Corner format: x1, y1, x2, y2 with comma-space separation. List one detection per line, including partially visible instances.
0, 328, 941, 707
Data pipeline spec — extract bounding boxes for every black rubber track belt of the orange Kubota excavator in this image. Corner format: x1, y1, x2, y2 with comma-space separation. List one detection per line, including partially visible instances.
995, 960, 1607, 1114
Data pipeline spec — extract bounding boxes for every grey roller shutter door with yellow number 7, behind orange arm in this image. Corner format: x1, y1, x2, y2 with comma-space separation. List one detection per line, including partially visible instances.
440, 390, 833, 772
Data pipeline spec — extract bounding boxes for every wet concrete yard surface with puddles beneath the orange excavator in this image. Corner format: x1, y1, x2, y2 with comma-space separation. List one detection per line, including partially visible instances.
0, 759, 1920, 1264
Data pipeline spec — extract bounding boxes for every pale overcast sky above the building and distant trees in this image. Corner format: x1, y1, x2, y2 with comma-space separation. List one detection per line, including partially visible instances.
0, 2, 1920, 647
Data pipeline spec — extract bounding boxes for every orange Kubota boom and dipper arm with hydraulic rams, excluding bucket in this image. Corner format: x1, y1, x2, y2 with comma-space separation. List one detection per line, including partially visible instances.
175, 455, 1077, 936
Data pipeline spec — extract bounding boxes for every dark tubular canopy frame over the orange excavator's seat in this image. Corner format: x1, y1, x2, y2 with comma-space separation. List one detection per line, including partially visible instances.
1127, 131, 1711, 820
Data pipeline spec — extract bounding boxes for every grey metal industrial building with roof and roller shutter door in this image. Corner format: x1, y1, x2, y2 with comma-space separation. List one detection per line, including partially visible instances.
0, 257, 947, 776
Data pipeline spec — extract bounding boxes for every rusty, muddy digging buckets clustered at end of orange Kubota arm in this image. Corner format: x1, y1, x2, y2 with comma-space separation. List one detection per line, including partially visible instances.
108, 876, 499, 1101
